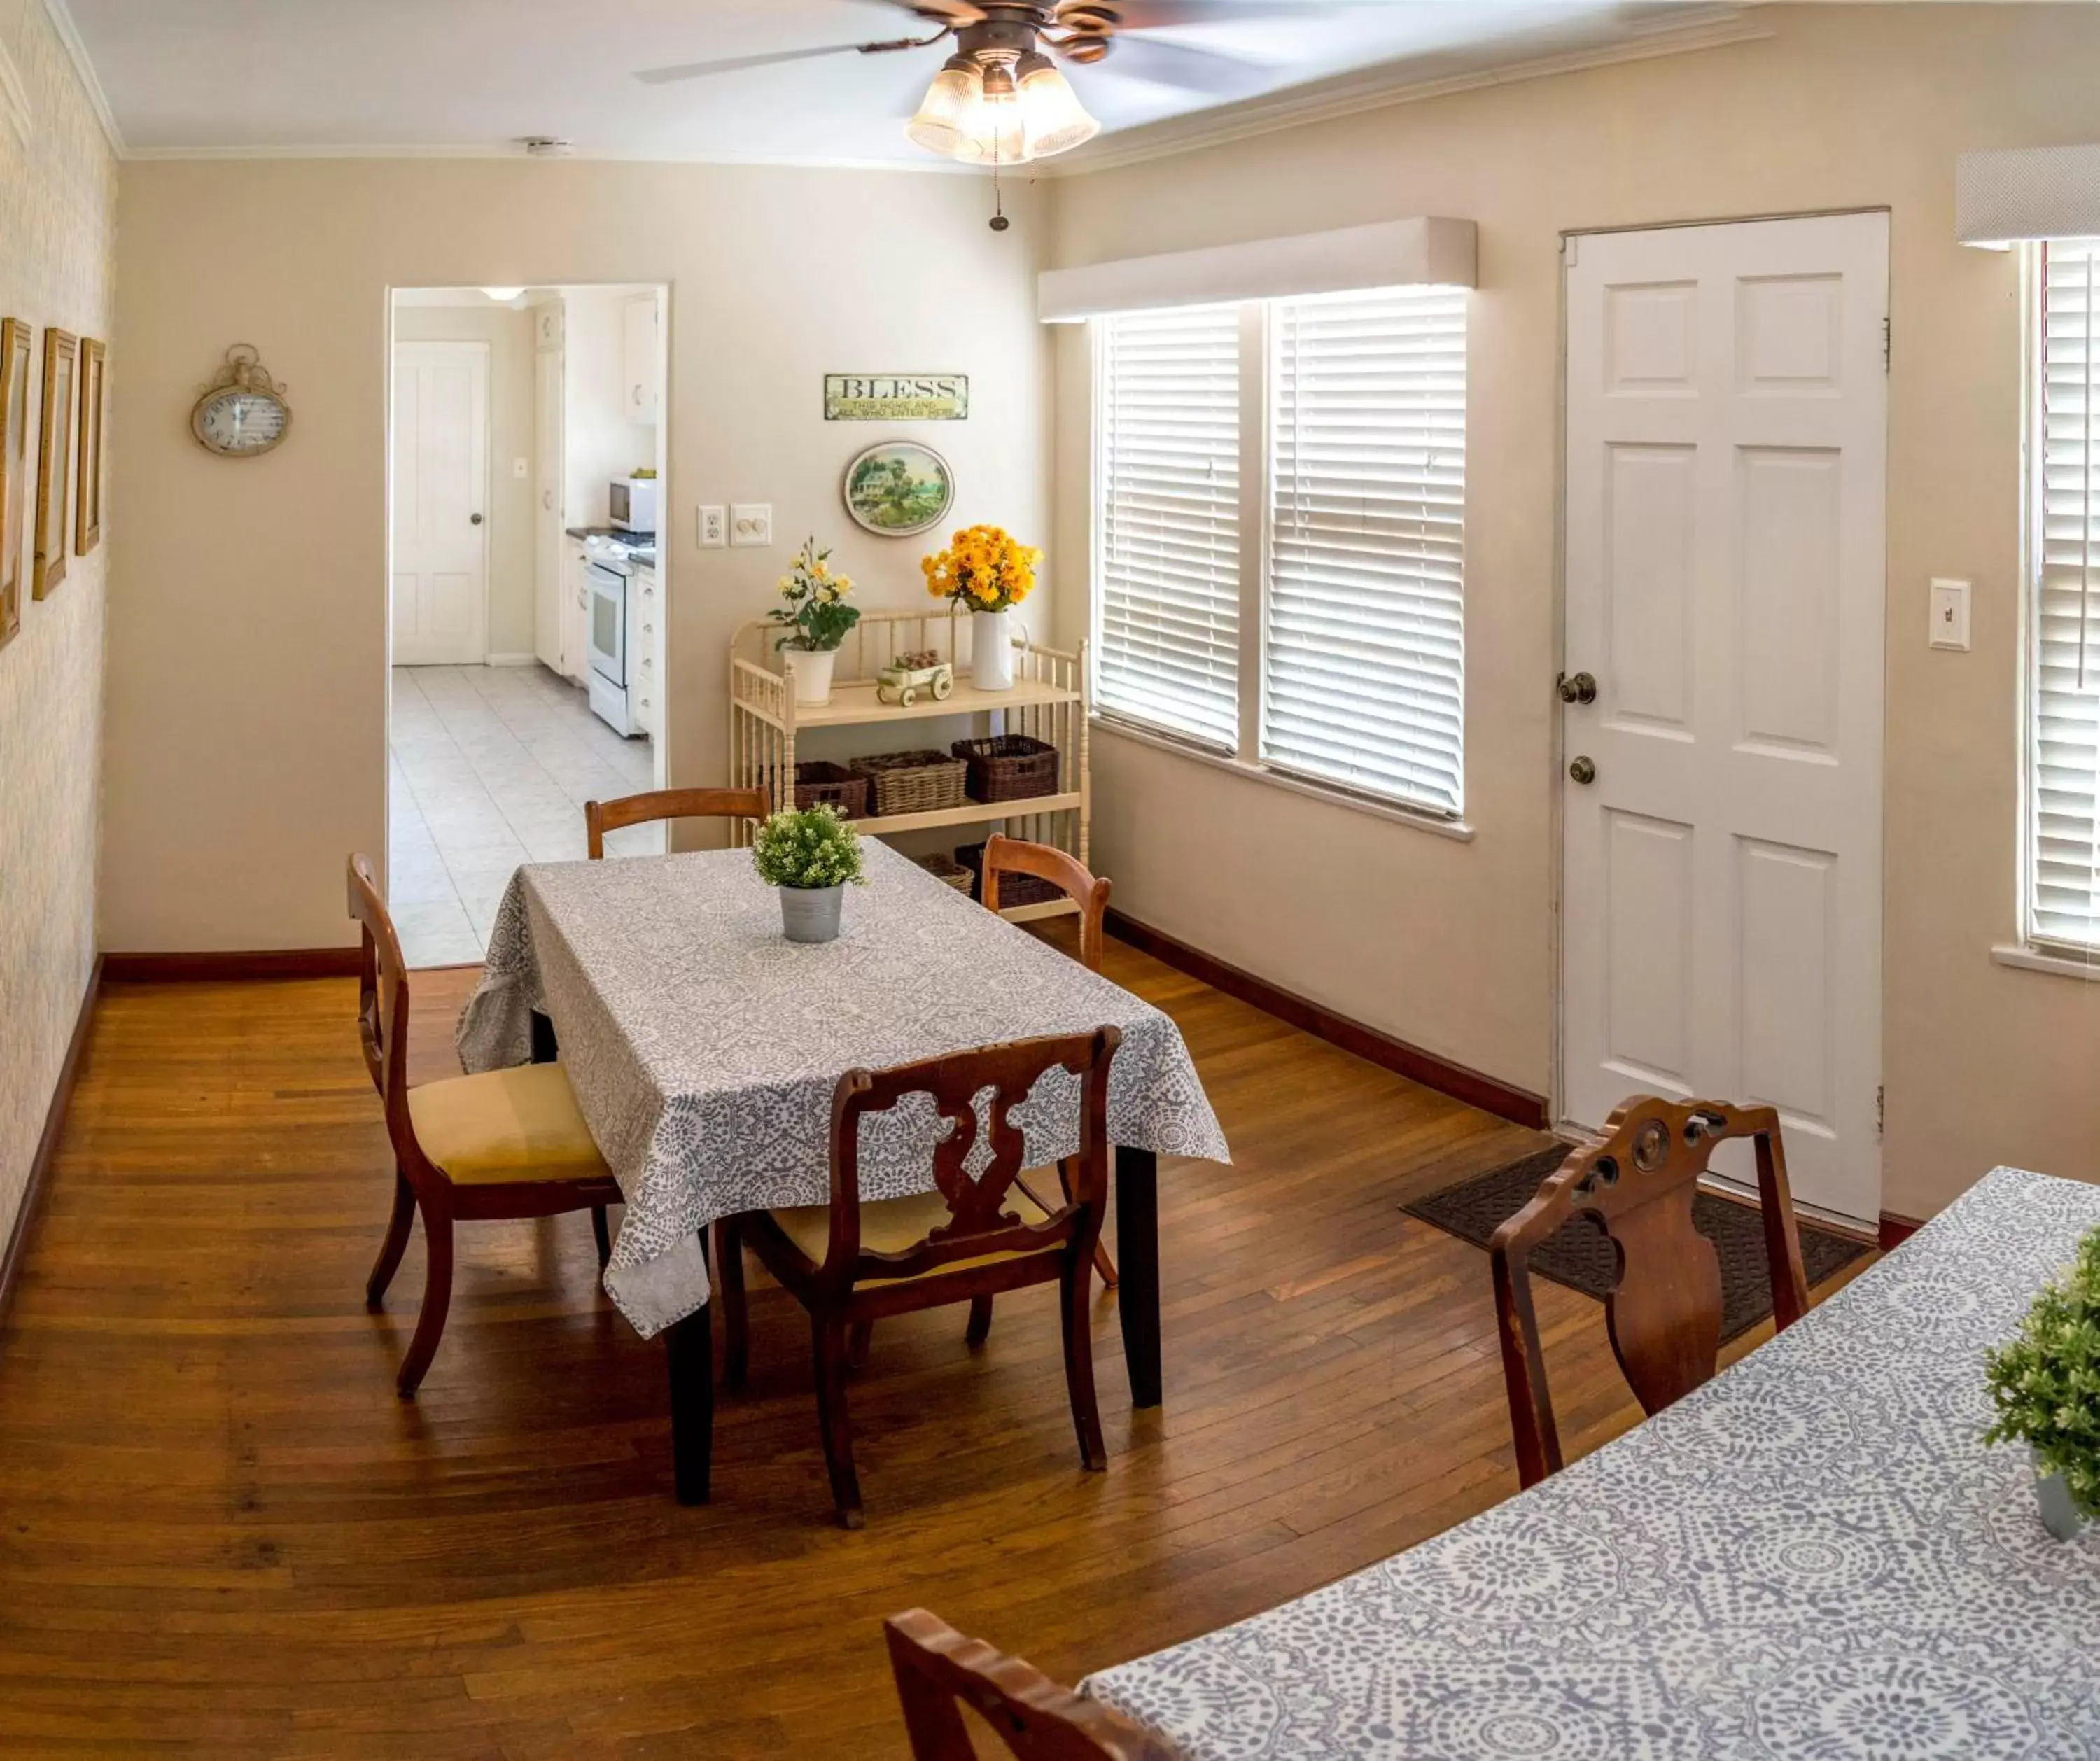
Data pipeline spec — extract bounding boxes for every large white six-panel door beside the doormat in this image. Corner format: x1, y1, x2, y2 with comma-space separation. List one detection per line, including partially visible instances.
1560, 214, 1888, 1219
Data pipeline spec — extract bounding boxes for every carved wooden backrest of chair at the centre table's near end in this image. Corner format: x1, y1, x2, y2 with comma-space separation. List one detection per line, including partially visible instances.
821, 1026, 1124, 1295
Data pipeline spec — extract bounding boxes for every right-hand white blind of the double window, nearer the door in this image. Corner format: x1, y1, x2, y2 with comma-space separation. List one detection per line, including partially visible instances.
1262, 288, 1466, 817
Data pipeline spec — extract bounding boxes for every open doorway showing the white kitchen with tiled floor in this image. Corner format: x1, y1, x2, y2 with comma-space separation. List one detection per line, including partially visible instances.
386, 286, 668, 967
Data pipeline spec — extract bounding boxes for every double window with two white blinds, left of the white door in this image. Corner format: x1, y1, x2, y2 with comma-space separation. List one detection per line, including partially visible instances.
1094, 288, 1466, 819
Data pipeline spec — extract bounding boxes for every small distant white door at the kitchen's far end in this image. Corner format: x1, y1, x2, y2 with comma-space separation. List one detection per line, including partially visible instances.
393, 342, 489, 668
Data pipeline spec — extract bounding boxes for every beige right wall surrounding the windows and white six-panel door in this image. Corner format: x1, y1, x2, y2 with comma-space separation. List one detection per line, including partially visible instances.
1052, 6, 2100, 1213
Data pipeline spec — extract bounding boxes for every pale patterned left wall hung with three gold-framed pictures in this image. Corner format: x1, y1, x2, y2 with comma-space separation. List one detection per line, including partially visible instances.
0, 0, 124, 1240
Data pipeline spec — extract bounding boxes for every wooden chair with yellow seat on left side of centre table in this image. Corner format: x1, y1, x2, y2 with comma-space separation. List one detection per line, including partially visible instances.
351, 857, 622, 1398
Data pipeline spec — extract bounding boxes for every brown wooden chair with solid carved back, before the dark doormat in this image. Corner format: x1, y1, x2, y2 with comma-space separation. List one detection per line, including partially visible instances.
1489, 1095, 1808, 1486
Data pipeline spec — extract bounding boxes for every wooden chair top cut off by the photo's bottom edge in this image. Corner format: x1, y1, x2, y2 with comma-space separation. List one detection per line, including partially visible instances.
882, 1608, 1174, 1761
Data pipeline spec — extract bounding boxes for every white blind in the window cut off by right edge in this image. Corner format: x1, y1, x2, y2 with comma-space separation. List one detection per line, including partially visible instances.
2026, 239, 2100, 948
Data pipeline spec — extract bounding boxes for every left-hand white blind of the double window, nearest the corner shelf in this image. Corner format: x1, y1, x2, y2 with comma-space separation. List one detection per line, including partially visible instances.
1094, 307, 1239, 752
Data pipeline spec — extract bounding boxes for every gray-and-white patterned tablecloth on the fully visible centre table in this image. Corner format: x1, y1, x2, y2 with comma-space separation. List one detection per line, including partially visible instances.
456, 840, 1228, 1337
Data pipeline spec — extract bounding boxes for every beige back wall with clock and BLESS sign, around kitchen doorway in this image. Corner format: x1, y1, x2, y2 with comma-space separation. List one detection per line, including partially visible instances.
103, 160, 1048, 948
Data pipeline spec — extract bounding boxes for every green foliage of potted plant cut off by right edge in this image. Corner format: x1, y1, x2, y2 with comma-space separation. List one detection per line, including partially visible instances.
1984, 1228, 2100, 1517
